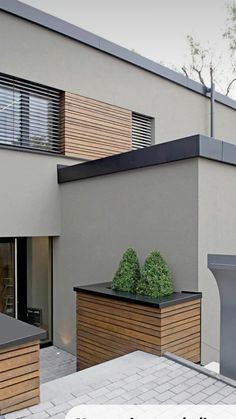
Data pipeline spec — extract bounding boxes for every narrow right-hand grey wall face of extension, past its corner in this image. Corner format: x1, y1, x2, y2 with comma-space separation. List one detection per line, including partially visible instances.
198, 159, 236, 363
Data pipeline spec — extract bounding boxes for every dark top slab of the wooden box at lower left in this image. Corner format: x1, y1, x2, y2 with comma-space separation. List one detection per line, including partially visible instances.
0, 313, 46, 350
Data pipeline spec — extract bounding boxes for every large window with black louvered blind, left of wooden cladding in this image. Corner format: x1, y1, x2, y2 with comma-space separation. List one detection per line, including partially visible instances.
0, 73, 60, 153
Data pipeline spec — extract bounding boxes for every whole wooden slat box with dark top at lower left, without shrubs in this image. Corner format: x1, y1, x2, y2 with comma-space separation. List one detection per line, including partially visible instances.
0, 313, 46, 415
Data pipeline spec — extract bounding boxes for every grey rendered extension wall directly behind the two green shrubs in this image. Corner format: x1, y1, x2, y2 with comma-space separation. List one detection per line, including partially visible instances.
54, 159, 198, 352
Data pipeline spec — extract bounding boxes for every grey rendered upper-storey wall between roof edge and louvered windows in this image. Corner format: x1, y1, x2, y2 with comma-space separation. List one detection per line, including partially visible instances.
0, 12, 236, 143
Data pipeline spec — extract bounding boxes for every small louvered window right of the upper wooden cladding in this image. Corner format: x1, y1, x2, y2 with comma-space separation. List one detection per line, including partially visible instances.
132, 112, 153, 150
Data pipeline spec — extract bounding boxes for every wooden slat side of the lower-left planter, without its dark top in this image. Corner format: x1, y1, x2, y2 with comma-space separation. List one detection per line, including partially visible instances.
0, 341, 39, 415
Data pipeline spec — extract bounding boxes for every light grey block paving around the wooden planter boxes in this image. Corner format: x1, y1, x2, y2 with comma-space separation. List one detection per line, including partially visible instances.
5, 347, 236, 419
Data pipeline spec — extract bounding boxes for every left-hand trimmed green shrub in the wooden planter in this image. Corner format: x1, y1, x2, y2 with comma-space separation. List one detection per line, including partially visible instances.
112, 248, 140, 293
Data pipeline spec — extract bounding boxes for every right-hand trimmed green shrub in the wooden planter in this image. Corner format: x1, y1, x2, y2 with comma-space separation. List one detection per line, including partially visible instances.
136, 251, 173, 298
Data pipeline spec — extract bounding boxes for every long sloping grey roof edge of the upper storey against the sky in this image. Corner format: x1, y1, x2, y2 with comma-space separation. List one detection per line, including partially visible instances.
0, 0, 236, 110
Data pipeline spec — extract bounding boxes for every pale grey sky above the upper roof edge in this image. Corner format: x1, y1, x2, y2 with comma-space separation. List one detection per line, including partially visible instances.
20, 0, 230, 92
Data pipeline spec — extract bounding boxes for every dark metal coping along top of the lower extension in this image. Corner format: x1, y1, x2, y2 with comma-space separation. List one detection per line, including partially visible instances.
58, 134, 236, 183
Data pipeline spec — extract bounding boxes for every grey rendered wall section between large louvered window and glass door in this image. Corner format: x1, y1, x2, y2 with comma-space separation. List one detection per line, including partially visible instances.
0, 149, 78, 237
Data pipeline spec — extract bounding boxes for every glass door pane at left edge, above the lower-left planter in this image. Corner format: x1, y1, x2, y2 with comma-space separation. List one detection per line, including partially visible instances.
0, 239, 17, 317
